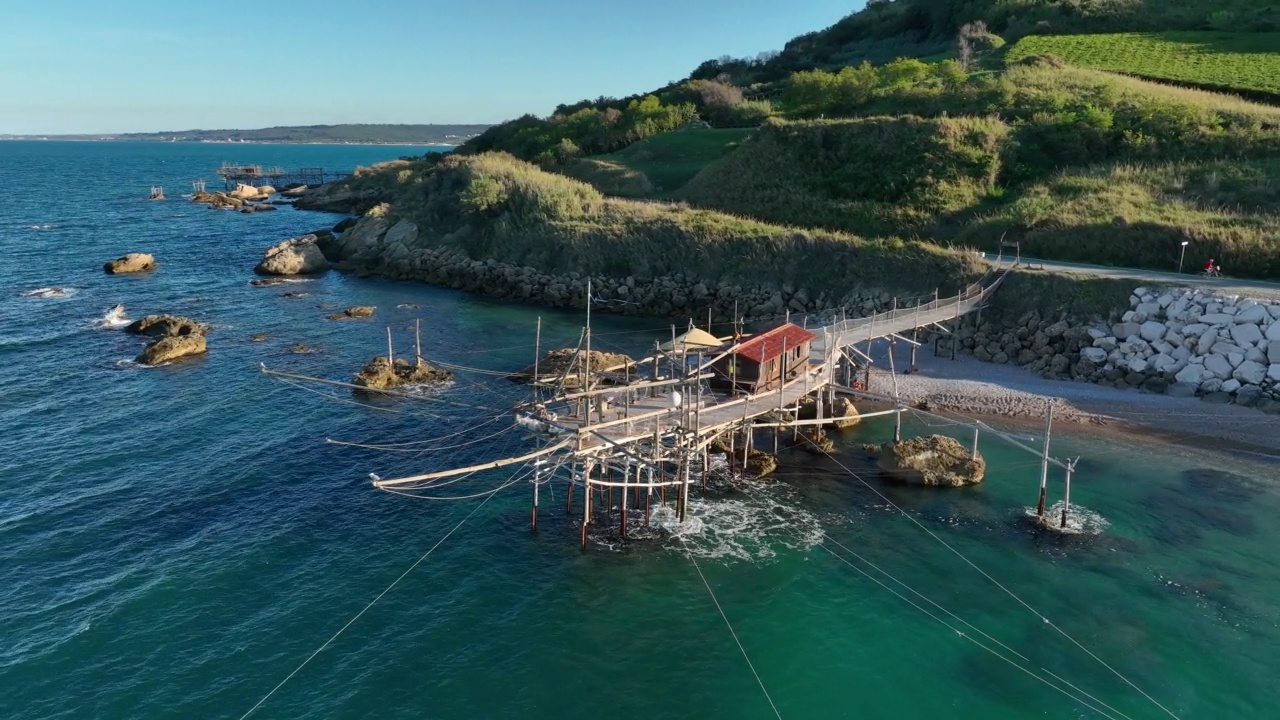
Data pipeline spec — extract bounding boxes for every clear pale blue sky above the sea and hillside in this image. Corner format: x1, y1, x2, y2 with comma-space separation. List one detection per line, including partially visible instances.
0, 0, 864, 133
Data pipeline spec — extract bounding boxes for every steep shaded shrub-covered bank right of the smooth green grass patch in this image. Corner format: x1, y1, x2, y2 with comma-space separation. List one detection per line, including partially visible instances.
681, 117, 1009, 236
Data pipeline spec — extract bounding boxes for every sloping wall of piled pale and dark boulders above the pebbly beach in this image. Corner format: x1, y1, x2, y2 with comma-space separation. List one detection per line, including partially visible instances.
957, 287, 1280, 411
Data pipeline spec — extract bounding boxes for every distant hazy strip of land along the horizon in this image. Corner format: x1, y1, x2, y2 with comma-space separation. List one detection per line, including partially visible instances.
110, 124, 490, 145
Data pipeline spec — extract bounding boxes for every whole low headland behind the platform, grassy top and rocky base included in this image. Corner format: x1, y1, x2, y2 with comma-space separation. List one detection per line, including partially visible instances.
298, 154, 980, 319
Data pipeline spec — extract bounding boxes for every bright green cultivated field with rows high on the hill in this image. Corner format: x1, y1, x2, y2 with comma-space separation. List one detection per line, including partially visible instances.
1006, 32, 1280, 100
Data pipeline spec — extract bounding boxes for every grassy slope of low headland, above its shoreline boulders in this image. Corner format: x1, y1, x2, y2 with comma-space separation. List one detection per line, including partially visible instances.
343, 154, 977, 293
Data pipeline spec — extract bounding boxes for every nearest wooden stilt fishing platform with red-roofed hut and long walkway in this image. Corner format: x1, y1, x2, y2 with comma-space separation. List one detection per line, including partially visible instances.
355, 254, 1085, 548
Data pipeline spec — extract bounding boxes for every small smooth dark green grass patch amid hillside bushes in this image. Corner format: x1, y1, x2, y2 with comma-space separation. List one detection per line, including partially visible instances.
559, 128, 753, 197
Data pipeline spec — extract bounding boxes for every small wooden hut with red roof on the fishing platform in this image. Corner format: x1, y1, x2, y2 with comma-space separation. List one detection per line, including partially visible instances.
710, 323, 818, 393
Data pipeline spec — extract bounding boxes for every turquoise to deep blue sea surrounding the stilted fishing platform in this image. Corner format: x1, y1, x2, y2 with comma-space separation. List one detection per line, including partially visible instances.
0, 142, 1280, 720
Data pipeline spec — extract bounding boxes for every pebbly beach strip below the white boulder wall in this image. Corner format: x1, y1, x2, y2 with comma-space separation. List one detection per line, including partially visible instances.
869, 347, 1280, 454
